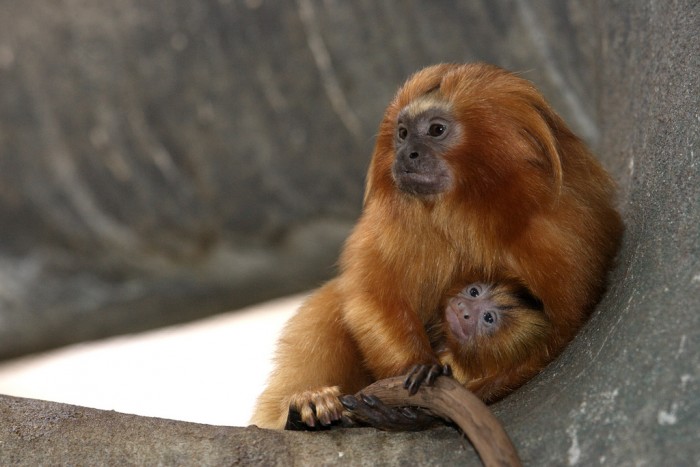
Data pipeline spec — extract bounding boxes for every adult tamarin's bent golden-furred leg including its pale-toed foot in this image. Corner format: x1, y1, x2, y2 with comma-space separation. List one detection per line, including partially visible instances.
251, 282, 372, 429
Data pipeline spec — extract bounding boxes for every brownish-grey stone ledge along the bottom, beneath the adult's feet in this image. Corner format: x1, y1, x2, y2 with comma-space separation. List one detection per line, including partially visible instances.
0, 396, 477, 466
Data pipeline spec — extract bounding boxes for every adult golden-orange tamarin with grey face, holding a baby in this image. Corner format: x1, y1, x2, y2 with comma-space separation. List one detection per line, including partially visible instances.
252, 64, 622, 428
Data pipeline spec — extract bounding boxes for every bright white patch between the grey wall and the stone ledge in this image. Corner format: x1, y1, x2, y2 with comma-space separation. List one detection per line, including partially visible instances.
0, 296, 303, 426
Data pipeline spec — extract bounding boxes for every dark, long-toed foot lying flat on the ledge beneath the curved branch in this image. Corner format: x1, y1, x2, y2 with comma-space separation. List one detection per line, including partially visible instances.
340, 393, 444, 431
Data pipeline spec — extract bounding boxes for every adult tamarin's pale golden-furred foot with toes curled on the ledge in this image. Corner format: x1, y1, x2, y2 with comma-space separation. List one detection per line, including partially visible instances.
285, 386, 343, 430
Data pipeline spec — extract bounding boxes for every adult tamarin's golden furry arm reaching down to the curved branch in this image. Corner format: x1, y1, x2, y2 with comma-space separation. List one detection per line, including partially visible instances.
340, 218, 446, 379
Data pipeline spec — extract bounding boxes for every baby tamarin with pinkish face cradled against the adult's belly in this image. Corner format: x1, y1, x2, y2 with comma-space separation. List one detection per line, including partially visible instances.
427, 281, 552, 402
